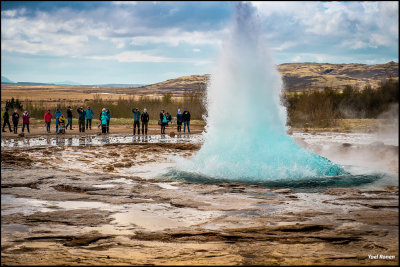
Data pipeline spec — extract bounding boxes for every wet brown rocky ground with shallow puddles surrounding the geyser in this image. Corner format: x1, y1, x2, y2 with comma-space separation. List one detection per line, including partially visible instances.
1, 133, 398, 265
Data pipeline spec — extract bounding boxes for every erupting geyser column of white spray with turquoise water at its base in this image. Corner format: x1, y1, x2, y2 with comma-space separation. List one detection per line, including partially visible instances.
176, 3, 344, 181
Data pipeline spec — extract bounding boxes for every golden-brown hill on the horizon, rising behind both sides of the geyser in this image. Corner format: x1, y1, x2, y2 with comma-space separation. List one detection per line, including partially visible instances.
140, 62, 399, 94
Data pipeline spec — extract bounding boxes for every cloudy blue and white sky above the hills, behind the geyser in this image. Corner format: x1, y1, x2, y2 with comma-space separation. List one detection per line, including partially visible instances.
1, 1, 399, 84
